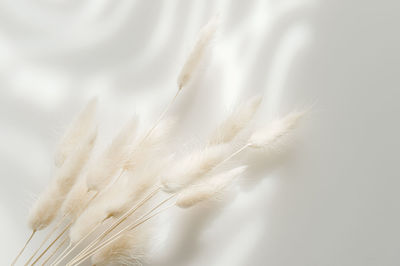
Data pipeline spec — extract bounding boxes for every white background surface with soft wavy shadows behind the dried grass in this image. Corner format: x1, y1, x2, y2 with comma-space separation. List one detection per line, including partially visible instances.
0, 0, 400, 266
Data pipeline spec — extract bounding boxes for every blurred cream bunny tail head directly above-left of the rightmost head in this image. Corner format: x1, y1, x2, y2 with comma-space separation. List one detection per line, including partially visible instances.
209, 96, 262, 145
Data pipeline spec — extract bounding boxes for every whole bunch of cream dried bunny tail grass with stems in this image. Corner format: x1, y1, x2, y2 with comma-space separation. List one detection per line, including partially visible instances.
12, 18, 304, 265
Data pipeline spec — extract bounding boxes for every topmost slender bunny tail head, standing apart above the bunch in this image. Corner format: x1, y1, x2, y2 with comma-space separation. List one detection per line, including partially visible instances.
178, 16, 219, 90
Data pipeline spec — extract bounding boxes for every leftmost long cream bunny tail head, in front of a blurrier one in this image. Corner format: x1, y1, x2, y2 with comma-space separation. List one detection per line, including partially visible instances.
28, 130, 97, 230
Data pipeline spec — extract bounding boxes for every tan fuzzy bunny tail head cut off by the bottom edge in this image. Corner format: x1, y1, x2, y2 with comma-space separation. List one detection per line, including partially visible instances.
91, 214, 151, 266
